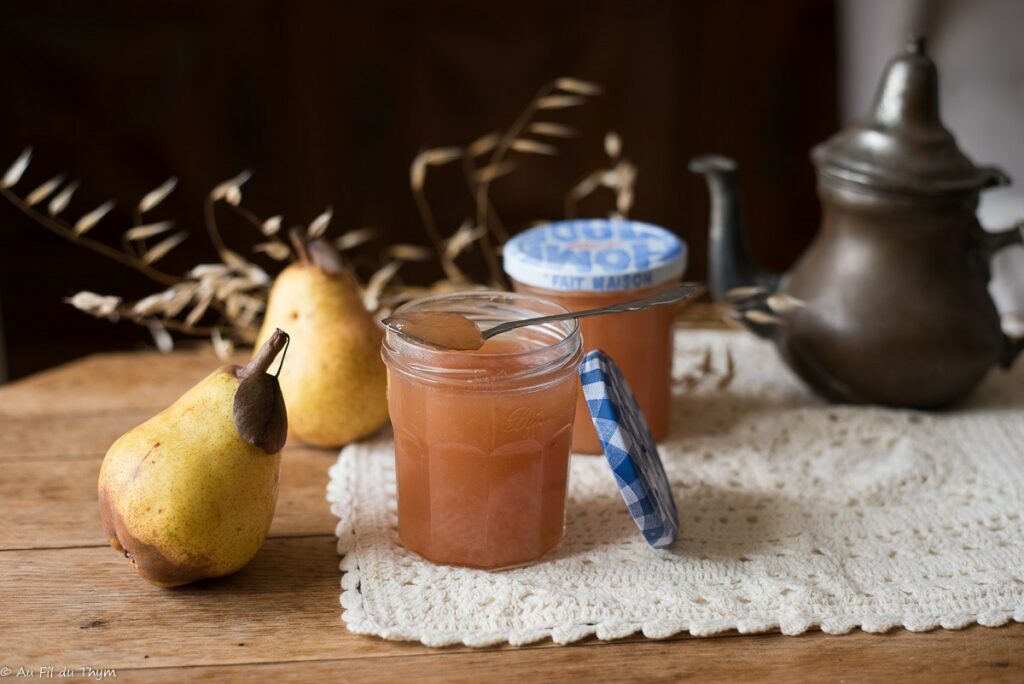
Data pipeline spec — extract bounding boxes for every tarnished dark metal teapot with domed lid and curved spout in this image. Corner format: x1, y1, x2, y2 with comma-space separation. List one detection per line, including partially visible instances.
690, 39, 1024, 409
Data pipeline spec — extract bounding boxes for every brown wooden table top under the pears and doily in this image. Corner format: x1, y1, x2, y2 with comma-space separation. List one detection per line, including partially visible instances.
0, 327, 1024, 682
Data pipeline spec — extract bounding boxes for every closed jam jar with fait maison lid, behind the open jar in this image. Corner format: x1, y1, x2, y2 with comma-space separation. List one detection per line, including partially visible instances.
504, 219, 686, 454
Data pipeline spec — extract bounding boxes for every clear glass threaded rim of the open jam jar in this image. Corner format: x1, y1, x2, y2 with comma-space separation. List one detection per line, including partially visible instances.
381, 290, 583, 384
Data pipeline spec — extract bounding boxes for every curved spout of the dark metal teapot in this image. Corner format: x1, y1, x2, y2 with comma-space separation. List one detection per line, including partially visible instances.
689, 155, 781, 301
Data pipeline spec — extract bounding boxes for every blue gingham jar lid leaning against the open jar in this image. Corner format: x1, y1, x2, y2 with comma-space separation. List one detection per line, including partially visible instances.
580, 349, 679, 549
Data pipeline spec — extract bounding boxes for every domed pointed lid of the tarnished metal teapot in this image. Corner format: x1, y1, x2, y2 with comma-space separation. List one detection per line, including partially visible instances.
811, 35, 1011, 195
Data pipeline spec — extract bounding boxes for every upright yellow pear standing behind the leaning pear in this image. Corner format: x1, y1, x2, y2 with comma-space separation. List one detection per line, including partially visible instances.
256, 230, 388, 446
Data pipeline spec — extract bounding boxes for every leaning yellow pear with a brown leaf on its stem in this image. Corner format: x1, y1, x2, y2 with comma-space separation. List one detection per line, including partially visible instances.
98, 330, 288, 587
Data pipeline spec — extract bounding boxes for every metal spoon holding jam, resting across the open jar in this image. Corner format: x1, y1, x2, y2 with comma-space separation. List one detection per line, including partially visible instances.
381, 283, 703, 351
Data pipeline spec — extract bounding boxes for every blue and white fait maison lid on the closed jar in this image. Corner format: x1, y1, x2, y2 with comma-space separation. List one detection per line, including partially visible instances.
503, 219, 687, 292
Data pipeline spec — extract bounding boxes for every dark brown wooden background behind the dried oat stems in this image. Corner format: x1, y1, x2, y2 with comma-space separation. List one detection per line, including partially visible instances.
0, 0, 837, 378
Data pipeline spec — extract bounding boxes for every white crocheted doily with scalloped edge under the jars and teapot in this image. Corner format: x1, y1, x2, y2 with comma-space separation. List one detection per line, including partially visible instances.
328, 330, 1024, 646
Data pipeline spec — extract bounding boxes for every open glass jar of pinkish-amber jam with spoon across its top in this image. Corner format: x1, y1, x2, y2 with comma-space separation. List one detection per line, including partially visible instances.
382, 292, 583, 569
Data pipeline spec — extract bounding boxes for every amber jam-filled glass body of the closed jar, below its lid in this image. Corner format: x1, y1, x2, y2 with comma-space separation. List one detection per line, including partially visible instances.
513, 280, 679, 454
